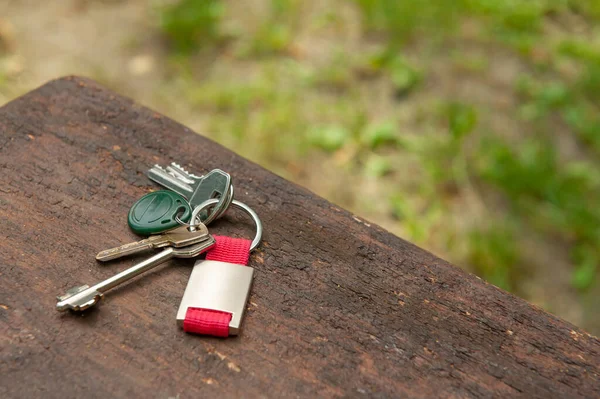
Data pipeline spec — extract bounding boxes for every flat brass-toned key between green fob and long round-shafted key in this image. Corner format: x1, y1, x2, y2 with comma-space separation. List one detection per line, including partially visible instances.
96, 224, 211, 262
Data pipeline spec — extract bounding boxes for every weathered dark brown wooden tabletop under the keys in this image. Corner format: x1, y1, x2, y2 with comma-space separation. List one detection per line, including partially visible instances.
0, 78, 600, 398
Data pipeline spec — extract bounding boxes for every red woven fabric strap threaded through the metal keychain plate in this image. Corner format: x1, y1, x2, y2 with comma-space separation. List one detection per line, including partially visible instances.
183, 236, 251, 337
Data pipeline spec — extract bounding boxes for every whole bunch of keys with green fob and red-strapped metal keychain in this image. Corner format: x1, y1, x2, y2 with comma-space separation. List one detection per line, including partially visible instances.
56, 163, 262, 336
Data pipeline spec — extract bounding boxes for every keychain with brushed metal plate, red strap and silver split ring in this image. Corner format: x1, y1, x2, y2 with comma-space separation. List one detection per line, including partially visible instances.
177, 199, 262, 337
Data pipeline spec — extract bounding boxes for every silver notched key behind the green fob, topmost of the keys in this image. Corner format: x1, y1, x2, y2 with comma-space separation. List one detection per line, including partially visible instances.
148, 163, 233, 224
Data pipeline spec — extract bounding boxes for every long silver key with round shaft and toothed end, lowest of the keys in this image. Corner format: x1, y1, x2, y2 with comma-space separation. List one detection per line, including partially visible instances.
56, 236, 215, 312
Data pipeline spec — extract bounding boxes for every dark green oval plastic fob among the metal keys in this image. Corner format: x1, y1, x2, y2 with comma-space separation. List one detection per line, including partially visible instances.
127, 190, 192, 235
